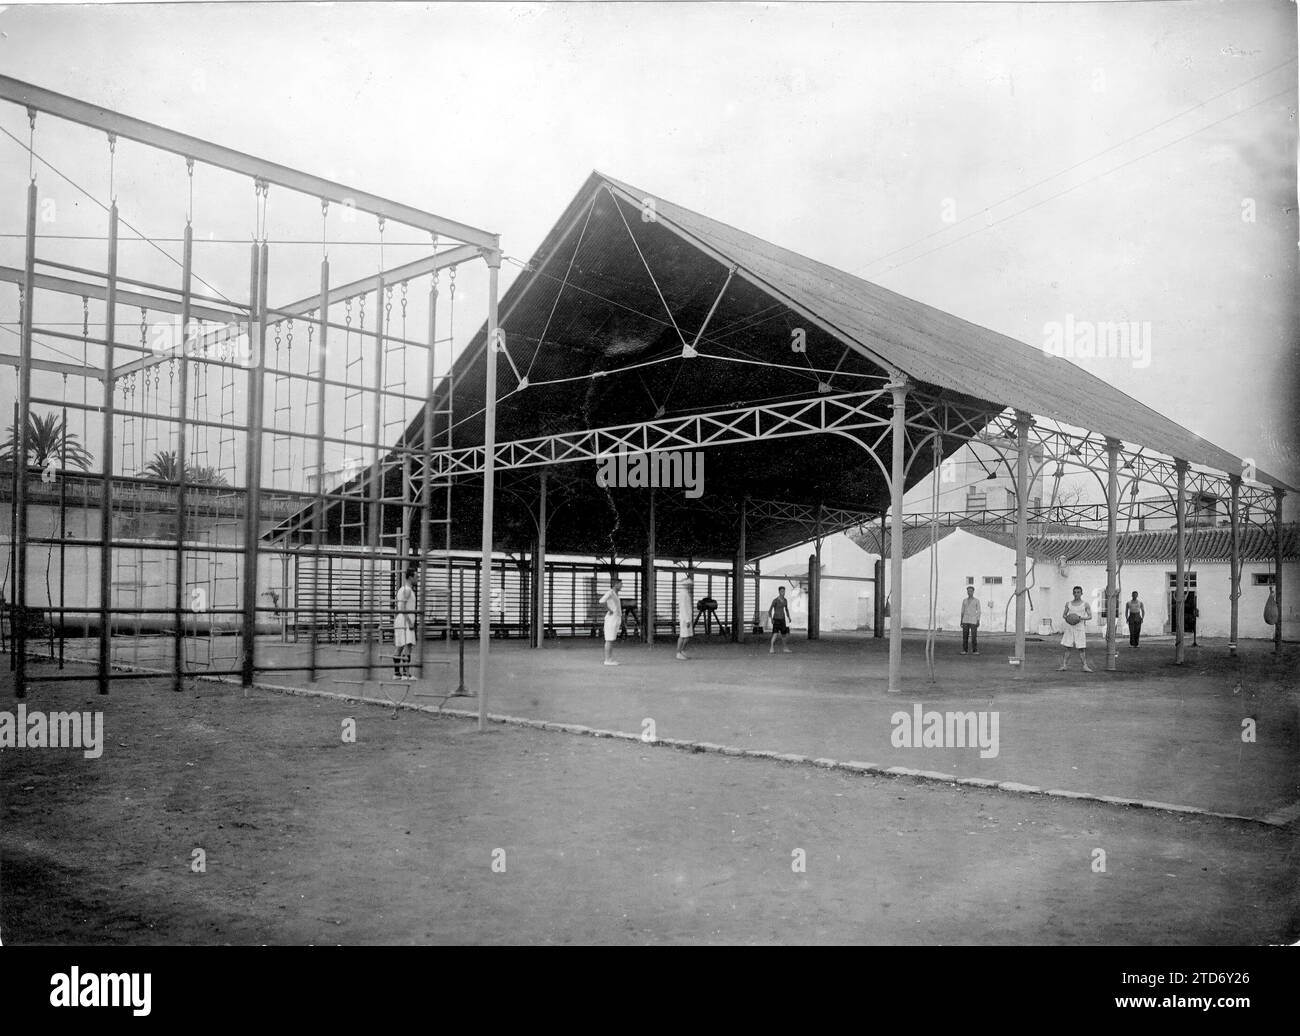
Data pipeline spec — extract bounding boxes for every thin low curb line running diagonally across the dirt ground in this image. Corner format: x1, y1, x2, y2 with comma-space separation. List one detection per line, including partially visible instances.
218, 676, 1284, 828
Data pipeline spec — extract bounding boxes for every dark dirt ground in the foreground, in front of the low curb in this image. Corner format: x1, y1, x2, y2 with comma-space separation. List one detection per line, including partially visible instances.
0, 655, 1300, 945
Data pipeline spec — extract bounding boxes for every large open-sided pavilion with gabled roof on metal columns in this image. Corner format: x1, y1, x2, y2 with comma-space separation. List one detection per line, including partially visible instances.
277, 173, 1288, 707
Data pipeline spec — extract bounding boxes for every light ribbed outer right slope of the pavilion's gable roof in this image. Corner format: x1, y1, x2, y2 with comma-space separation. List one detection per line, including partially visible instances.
593, 173, 1291, 489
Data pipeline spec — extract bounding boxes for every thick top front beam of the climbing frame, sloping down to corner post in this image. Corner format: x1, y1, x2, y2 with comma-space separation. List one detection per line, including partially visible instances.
0, 75, 501, 251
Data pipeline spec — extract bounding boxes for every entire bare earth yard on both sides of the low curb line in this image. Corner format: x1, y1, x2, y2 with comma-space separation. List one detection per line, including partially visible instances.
0, 638, 1300, 945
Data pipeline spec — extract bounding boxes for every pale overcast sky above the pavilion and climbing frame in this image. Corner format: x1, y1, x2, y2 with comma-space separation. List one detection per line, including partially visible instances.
0, 0, 1300, 506
